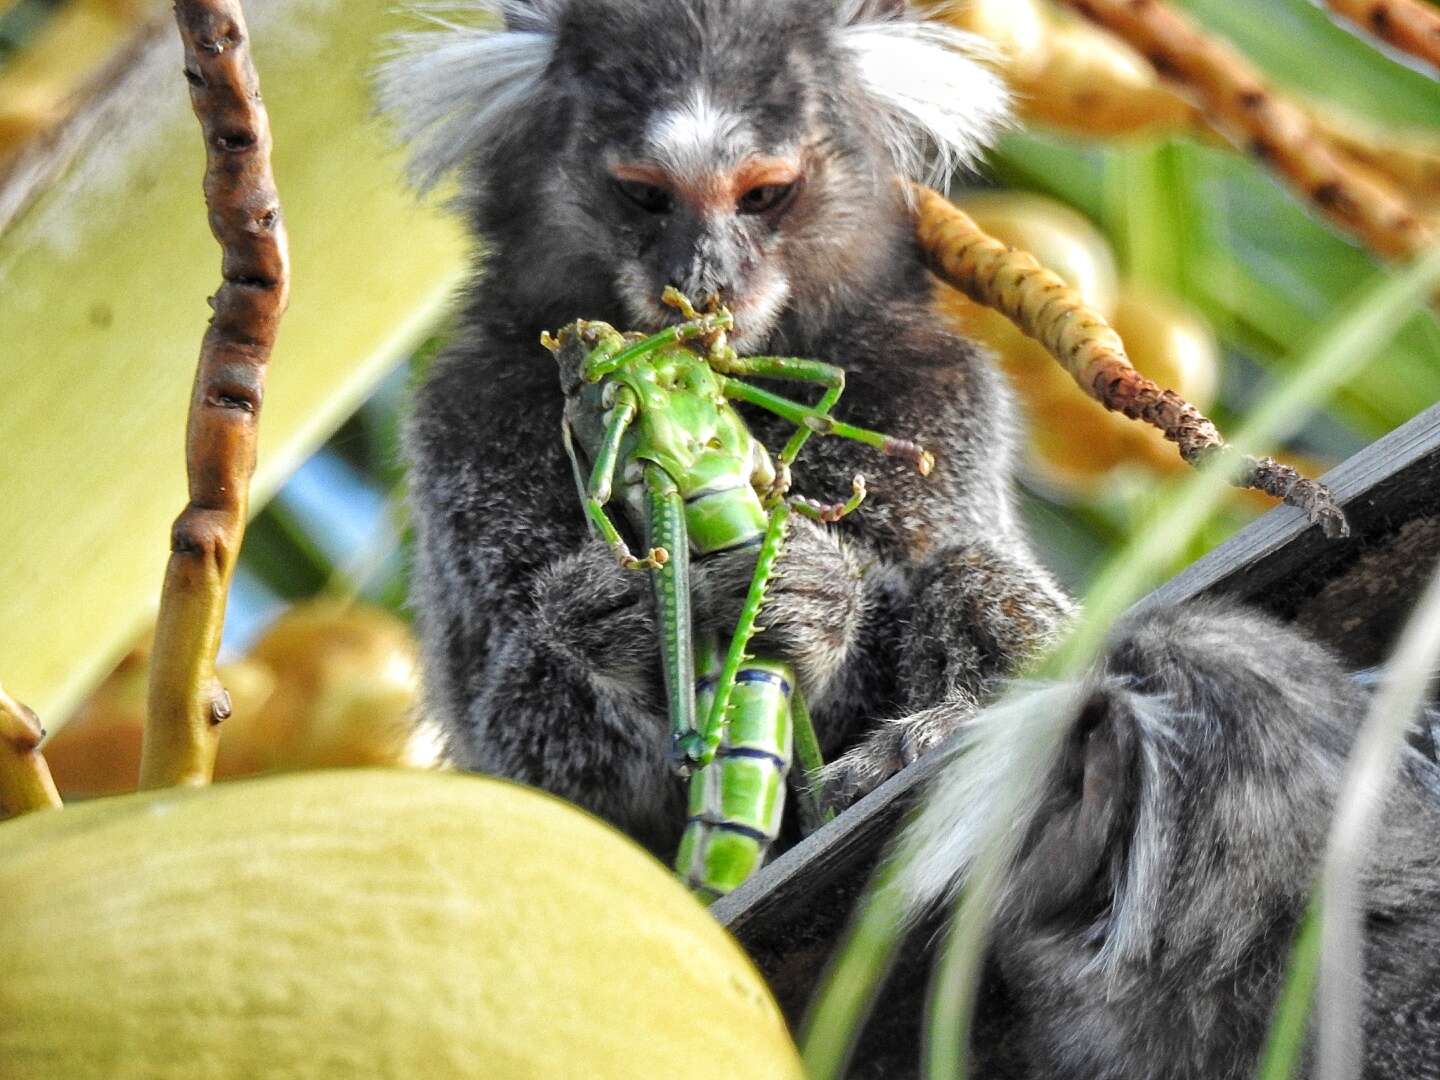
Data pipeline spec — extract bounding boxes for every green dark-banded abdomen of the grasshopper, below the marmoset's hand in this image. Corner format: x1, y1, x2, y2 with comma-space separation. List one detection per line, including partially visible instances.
675, 648, 795, 900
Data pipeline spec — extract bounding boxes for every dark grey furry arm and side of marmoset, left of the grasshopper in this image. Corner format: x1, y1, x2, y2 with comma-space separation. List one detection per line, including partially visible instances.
406, 340, 684, 857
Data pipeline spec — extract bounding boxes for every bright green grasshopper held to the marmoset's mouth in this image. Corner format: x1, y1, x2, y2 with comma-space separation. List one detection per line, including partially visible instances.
541, 288, 935, 901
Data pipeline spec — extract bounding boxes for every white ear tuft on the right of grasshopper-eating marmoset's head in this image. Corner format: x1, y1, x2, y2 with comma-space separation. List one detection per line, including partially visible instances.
840, 0, 1009, 192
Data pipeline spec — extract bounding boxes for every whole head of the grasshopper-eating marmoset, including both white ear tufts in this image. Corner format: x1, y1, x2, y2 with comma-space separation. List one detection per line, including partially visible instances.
382, 0, 1005, 338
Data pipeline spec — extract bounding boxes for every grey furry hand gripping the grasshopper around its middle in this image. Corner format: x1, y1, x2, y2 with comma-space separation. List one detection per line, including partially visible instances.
690, 520, 865, 700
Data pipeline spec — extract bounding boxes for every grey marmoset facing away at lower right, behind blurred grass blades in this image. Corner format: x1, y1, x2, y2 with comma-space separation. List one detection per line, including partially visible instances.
909, 603, 1440, 1080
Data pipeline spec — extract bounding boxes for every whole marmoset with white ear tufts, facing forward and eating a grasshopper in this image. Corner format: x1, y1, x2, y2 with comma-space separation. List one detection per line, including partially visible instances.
382, 0, 1070, 855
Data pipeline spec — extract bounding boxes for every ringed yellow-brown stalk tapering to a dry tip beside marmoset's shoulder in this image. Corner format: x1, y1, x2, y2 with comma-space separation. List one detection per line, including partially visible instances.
916, 187, 1348, 536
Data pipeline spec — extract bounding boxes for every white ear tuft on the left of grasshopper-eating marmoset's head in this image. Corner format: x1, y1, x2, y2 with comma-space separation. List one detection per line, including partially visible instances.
376, 0, 566, 192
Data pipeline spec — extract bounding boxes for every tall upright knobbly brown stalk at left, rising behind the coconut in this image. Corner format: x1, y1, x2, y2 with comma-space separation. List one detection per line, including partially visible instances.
140, 0, 289, 788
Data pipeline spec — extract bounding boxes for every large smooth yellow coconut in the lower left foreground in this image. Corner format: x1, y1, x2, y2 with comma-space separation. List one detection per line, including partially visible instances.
0, 769, 801, 1080
